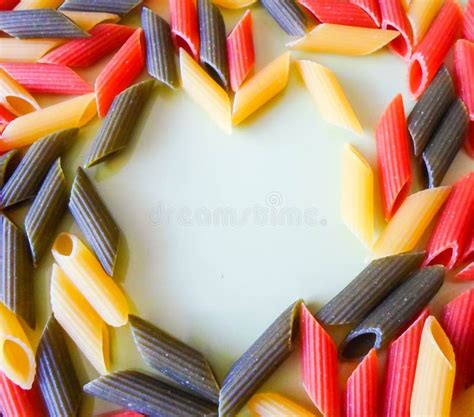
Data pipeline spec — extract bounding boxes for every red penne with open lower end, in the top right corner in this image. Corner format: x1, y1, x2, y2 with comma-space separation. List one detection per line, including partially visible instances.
408, 0, 462, 98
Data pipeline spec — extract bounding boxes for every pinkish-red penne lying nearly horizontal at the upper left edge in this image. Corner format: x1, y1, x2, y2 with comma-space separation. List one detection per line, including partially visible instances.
0, 63, 94, 95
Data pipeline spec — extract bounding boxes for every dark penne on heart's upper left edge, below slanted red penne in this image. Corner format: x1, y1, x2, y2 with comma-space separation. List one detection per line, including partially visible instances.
84, 80, 154, 168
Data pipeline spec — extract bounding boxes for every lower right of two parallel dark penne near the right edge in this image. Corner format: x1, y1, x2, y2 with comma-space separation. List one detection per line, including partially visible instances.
423, 98, 469, 188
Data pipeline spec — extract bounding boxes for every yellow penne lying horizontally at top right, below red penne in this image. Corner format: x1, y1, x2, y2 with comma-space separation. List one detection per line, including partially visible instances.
287, 23, 400, 56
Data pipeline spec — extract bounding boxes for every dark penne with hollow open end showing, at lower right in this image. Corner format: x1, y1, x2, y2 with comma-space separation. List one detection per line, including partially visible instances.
340, 266, 445, 358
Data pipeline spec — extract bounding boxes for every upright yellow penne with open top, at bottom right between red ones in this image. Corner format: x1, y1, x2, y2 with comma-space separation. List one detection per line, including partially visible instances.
410, 316, 456, 417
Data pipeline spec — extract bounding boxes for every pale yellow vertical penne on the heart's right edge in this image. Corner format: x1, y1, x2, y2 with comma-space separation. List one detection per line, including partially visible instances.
341, 144, 374, 246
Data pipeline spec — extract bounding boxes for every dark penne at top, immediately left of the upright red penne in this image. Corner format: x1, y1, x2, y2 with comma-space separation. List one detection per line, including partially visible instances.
141, 7, 178, 88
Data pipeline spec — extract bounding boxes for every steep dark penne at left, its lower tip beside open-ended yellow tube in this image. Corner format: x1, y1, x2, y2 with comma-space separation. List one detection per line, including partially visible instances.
25, 158, 67, 266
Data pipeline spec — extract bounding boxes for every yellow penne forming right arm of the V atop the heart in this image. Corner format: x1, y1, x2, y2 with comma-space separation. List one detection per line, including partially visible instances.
232, 52, 290, 125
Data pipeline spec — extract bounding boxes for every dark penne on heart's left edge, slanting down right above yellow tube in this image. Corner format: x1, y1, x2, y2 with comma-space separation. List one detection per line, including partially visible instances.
69, 168, 120, 276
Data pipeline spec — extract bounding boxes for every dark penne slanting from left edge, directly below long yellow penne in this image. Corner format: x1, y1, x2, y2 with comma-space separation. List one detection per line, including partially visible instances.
0, 129, 78, 208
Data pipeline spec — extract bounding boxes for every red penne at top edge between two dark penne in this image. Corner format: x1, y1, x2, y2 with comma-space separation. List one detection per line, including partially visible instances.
169, 0, 199, 62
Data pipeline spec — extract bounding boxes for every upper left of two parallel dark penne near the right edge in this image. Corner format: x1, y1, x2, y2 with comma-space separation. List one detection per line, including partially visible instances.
408, 65, 456, 156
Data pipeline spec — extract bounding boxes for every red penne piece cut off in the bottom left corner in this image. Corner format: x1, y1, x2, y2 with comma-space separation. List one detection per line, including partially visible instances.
0, 372, 48, 417
